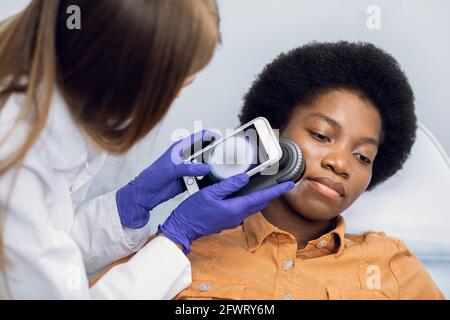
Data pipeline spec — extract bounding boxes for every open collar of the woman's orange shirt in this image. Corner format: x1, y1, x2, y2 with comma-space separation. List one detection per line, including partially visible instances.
243, 212, 345, 258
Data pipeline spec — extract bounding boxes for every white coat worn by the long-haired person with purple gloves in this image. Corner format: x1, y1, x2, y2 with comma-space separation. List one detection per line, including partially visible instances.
0, 92, 191, 299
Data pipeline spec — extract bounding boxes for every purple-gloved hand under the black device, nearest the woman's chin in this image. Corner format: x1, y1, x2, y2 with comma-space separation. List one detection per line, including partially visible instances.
158, 173, 294, 253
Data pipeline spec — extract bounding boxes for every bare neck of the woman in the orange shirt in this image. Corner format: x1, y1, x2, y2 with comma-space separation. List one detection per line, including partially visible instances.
262, 197, 333, 250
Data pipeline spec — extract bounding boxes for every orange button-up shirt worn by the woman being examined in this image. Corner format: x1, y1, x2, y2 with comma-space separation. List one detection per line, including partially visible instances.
176, 213, 445, 299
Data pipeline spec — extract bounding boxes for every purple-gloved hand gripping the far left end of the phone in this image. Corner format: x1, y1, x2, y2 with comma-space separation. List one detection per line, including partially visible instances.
116, 130, 220, 229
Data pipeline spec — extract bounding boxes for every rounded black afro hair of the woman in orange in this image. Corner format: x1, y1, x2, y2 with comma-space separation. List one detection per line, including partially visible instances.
239, 41, 417, 190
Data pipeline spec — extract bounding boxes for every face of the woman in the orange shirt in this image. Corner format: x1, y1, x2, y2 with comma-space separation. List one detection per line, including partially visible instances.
281, 90, 381, 221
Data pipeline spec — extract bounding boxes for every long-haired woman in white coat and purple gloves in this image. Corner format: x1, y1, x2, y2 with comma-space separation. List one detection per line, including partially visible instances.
0, 0, 292, 299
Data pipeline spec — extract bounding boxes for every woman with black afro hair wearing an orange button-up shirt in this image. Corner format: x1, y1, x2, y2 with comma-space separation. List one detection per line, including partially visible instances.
176, 42, 444, 299
